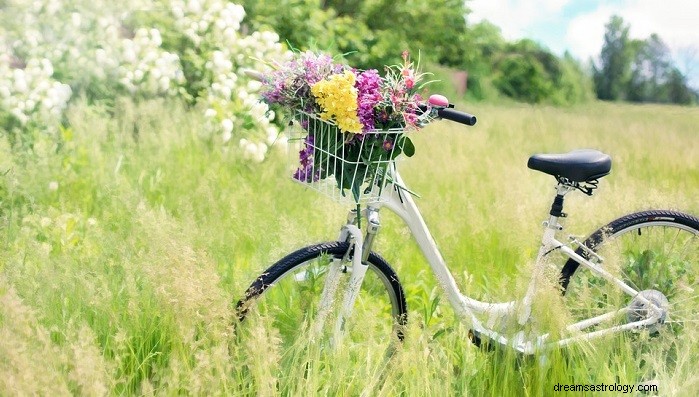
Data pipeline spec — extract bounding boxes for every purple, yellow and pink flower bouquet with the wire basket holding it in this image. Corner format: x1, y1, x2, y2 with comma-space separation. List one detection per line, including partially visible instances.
262, 52, 429, 203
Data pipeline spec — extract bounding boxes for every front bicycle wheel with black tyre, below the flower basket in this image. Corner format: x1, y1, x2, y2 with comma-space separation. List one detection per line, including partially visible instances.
237, 242, 407, 354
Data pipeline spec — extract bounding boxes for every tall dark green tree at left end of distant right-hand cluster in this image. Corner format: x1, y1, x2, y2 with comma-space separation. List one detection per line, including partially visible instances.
593, 15, 633, 100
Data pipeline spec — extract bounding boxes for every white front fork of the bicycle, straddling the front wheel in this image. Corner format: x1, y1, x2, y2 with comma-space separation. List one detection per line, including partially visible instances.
313, 208, 381, 346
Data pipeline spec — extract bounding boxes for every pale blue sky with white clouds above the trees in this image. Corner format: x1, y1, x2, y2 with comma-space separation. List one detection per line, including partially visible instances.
466, 0, 699, 88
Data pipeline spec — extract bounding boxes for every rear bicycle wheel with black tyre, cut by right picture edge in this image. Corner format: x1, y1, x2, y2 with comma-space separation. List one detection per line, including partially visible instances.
561, 211, 699, 379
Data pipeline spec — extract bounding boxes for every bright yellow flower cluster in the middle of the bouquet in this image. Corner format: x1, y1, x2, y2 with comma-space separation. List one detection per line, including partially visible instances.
311, 70, 362, 133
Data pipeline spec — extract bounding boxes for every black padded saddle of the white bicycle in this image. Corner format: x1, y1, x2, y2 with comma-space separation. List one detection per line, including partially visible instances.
527, 149, 612, 182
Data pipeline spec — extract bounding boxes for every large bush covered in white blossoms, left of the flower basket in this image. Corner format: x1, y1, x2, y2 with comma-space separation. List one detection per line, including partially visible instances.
0, 0, 288, 161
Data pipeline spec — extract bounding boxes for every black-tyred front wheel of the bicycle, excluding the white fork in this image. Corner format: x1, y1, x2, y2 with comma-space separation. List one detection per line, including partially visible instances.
236, 241, 407, 349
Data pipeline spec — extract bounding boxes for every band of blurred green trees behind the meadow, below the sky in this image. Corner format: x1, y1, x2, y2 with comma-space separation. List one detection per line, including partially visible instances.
245, 0, 592, 104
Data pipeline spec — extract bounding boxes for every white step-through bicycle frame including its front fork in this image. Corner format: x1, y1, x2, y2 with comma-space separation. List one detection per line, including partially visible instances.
328, 169, 662, 354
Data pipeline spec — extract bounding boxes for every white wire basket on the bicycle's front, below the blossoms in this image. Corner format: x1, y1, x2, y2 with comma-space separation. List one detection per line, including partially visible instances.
289, 112, 412, 204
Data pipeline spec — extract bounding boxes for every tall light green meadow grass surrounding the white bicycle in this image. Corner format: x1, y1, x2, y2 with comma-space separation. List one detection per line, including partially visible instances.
0, 97, 699, 396
